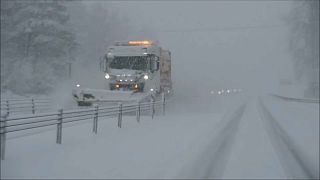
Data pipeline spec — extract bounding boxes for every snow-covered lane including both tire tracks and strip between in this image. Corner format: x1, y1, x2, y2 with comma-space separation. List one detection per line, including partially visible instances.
185, 96, 319, 179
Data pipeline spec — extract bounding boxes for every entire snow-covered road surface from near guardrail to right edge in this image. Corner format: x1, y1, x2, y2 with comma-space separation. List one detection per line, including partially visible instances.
1, 96, 319, 179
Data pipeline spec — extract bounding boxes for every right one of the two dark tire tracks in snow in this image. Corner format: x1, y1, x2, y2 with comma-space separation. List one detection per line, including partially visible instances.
259, 98, 319, 179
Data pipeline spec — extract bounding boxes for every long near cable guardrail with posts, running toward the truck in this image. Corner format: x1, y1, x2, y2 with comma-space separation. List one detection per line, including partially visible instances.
0, 95, 166, 160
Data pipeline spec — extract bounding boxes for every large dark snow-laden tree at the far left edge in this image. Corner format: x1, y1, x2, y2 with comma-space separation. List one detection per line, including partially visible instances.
1, 0, 77, 93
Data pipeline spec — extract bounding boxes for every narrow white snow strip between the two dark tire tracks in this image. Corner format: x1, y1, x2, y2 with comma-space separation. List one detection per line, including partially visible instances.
223, 101, 286, 179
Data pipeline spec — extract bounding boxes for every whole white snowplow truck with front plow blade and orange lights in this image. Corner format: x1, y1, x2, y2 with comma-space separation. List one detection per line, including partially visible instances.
73, 40, 172, 106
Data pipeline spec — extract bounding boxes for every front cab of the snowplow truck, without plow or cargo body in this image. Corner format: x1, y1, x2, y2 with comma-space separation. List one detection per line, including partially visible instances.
100, 41, 161, 93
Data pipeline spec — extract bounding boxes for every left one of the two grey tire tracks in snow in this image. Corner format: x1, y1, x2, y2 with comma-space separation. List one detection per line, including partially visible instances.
181, 103, 247, 179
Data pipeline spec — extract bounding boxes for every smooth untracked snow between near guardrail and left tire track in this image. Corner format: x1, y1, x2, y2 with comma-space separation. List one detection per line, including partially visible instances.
1, 114, 219, 179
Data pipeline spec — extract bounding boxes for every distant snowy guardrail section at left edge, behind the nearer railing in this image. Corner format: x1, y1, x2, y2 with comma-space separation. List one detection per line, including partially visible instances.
1, 98, 51, 115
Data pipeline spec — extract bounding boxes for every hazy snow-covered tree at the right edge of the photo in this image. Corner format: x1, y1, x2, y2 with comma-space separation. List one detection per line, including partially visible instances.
290, 0, 319, 96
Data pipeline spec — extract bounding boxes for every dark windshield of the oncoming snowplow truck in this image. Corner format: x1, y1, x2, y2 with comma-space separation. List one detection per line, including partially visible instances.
110, 56, 148, 70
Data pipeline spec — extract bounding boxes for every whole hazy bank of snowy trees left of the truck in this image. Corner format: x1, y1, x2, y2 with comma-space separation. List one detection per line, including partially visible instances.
1, 0, 130, 93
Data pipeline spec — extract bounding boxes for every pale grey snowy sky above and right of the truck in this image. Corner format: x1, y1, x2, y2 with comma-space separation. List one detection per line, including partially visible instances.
87, 1, 292, 96
